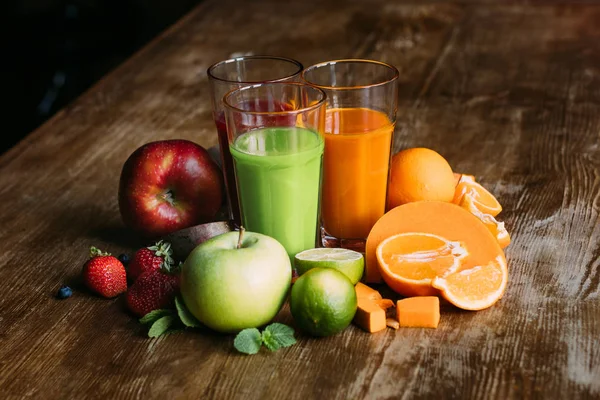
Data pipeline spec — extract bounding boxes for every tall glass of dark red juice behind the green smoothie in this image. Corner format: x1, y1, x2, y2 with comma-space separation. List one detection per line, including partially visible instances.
207, 56, 303, 225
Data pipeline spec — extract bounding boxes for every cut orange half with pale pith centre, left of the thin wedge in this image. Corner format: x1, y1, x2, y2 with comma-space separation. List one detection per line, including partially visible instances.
376, 232, 469, 296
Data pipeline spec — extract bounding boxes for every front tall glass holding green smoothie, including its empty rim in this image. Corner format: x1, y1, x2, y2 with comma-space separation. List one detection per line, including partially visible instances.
223, 83, 325, 259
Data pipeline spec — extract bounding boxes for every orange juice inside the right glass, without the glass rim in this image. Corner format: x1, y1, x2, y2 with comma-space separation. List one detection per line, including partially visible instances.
321, 108, 394, 239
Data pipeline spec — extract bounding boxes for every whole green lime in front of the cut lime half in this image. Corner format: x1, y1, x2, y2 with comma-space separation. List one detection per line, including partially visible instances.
290, 268, 356, 336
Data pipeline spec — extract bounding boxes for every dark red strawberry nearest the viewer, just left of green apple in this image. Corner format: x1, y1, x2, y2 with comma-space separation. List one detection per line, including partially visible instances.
127, 263, 179, 317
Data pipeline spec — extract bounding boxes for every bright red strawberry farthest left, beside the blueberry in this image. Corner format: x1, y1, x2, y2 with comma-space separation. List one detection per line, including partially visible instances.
83, 246, 127, 298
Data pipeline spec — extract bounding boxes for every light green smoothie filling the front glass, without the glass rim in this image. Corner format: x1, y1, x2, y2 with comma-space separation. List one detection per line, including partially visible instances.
229, 127, 324, 259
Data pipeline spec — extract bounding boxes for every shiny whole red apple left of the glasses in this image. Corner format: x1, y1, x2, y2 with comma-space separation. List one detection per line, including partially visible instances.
119, 140, 223, 237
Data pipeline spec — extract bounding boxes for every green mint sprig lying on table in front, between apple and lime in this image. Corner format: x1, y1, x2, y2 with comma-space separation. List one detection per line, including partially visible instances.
233, 322, 296, 354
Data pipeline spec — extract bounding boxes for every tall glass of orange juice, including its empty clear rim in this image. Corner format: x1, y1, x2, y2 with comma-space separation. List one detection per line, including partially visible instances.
301, 59, 399, 251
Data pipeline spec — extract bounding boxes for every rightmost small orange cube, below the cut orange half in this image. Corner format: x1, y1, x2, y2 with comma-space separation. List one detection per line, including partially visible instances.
396, 296, 440, 328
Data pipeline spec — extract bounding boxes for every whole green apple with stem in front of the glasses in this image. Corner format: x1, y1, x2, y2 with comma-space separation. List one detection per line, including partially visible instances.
181, 231, 292, 333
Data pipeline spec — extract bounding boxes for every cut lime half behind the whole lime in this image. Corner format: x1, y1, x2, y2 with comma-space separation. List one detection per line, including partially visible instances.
294, 248, 365, 285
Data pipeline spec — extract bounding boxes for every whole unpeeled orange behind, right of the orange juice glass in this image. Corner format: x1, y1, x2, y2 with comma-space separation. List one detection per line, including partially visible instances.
388, 147, 456, 209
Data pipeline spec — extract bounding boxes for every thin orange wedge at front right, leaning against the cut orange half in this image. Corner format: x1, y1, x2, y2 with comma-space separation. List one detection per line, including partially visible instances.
431, 257, 508, 311
